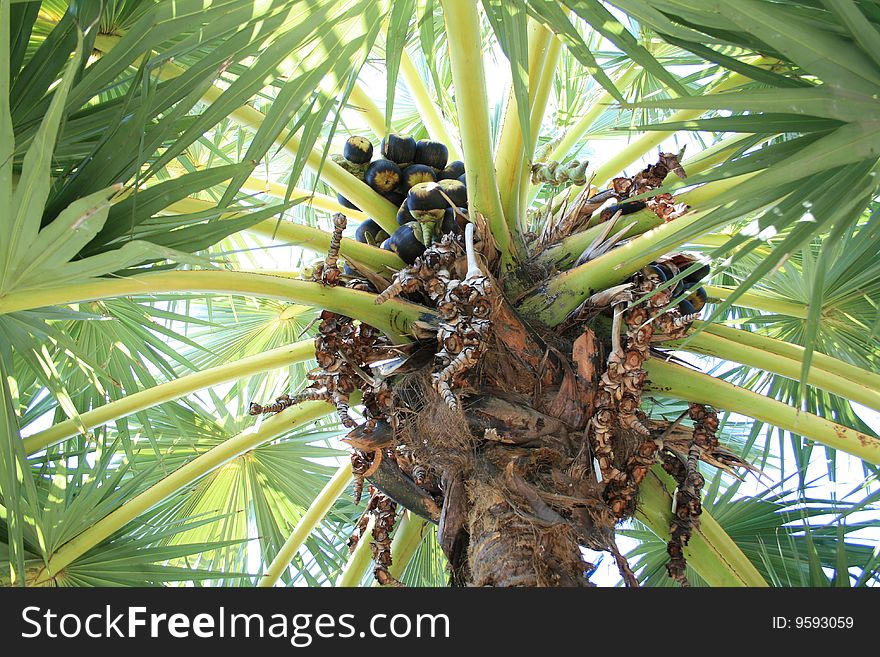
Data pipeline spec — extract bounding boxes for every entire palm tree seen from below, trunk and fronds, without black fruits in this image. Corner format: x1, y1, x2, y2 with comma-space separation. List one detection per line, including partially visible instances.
0, 0, 880, 586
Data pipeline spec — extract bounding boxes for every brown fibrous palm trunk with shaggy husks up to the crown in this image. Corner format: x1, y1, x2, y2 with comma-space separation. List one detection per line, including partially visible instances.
398, 288, 615, 586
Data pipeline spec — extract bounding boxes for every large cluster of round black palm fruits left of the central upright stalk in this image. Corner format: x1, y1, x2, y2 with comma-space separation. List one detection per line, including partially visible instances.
333, 133, 467, 264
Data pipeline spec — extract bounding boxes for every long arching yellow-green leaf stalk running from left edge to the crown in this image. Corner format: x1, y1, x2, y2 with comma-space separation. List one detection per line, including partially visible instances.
0, 270, 433, 340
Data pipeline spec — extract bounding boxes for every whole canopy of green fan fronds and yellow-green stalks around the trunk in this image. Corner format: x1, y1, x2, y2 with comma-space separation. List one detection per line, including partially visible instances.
0, 0, 880, 586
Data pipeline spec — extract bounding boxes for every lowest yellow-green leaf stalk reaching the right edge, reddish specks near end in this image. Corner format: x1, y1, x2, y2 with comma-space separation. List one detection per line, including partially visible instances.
645, 358, 880, 464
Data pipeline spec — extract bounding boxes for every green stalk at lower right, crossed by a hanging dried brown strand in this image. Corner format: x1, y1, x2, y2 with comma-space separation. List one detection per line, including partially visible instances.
636, 467, 767, 587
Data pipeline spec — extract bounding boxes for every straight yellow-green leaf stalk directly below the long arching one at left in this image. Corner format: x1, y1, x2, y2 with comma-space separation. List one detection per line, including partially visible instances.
23, 340, 315, 454
